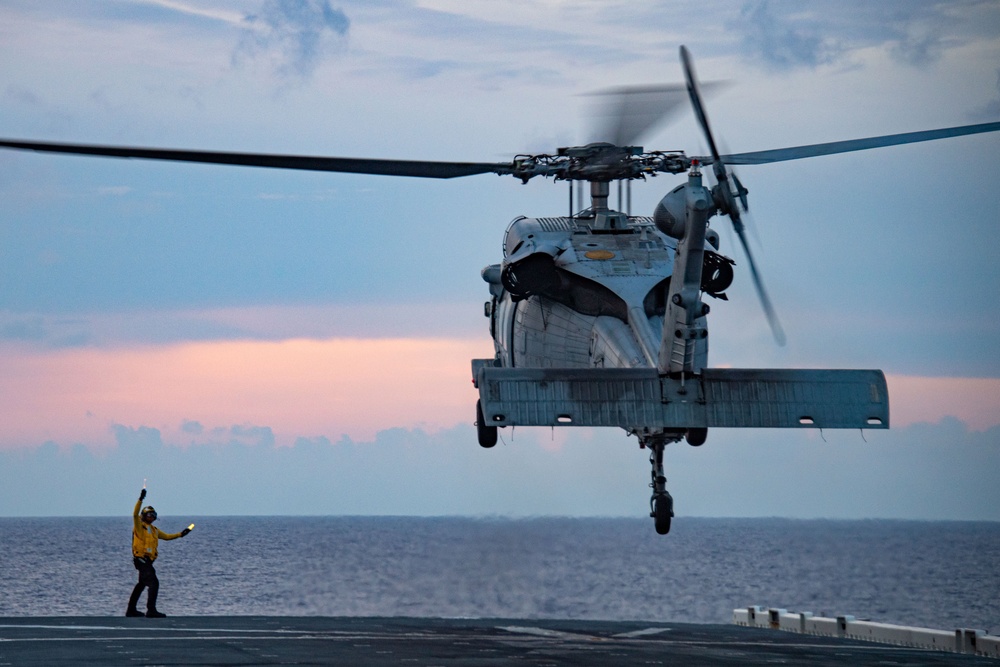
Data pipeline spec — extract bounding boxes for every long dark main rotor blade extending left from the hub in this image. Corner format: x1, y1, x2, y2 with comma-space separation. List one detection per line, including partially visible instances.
0, 139, 510, 178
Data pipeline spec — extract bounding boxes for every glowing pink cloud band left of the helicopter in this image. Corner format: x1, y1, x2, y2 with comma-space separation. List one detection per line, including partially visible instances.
0, 339, 491, 447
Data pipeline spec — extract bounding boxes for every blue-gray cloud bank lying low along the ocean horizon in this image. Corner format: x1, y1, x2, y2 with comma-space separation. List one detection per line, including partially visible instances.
0, 418, 1000, 522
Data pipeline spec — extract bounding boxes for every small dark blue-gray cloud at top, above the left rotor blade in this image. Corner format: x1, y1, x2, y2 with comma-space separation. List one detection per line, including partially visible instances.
234, 0, 351, 78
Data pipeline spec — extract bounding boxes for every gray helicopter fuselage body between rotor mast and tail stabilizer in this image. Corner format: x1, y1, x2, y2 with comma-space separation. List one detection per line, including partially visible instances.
483, 210, 718, 370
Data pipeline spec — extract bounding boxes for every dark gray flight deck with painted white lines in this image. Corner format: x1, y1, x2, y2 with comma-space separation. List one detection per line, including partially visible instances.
0, 616, 997, 666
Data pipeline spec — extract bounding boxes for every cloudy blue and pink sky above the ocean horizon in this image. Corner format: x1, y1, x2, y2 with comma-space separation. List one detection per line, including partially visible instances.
0, 0, 1000, 521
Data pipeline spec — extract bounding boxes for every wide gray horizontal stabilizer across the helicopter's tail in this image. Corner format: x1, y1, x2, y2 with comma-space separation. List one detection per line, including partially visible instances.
473, 359, 889, 429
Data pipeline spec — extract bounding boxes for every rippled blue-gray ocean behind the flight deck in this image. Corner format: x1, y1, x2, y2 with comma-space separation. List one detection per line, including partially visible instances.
0, 515, 1000, 632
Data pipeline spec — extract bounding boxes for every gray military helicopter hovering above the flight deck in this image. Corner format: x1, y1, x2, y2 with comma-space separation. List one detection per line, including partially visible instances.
0, 46, 1000, 534
